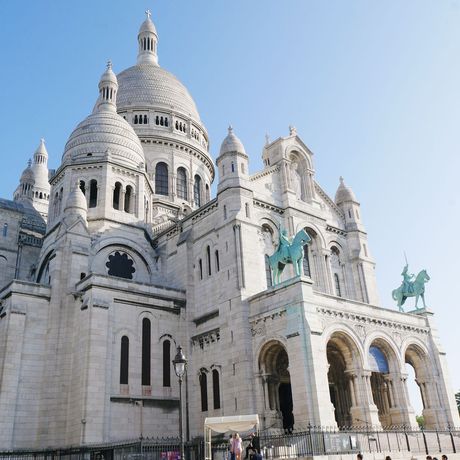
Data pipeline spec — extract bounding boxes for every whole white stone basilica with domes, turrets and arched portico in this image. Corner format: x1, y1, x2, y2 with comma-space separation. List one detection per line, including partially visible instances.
0, 14, 460, 450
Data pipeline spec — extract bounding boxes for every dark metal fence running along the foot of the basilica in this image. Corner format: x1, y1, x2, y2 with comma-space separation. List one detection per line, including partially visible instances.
0, 427, 460, 460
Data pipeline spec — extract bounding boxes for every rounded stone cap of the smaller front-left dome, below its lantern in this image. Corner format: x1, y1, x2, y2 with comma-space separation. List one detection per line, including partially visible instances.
62, 111, 145, 168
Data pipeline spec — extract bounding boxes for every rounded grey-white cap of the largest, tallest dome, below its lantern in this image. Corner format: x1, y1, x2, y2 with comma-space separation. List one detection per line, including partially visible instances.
117, 62, 200, 121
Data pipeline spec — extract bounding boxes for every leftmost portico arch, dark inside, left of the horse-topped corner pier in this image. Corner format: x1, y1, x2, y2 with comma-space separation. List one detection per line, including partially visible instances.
259, 341, 294, 432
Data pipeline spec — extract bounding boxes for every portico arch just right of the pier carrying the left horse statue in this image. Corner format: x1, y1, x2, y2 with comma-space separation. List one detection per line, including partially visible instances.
326, 332, 362, 427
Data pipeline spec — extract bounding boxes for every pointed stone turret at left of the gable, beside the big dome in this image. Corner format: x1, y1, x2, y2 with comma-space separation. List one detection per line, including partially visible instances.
216, 126, 249, 191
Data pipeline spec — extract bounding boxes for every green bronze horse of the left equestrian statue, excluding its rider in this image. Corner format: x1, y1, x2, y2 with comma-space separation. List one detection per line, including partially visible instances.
268, 229, 311, 285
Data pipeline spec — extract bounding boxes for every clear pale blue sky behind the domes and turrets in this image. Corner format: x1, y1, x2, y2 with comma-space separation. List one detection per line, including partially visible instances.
0, 0, 460, 416
